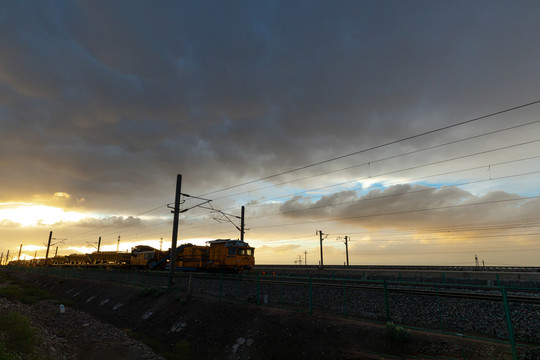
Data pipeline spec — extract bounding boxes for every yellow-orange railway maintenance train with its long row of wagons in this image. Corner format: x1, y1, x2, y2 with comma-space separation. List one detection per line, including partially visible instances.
9, 239, 255, 272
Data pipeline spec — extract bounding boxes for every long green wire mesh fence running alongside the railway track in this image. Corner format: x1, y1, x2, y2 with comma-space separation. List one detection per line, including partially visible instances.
5, 267, 540, 359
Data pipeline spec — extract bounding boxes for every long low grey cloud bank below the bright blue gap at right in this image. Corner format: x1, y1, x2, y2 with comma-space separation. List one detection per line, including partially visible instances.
280, 185, 540, 229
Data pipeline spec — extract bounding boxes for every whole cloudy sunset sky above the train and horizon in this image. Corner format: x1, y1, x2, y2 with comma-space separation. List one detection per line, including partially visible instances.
0, 0, 540, 266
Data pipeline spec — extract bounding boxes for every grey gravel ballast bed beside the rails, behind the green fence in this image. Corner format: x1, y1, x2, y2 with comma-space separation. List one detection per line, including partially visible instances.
178, 278, 540, 343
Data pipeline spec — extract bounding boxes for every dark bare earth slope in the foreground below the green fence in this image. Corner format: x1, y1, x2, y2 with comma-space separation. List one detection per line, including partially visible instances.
0, 272, 540, 360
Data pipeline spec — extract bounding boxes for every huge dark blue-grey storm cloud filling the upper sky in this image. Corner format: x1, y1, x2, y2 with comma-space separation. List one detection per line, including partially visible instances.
0, 1, 540, 208
